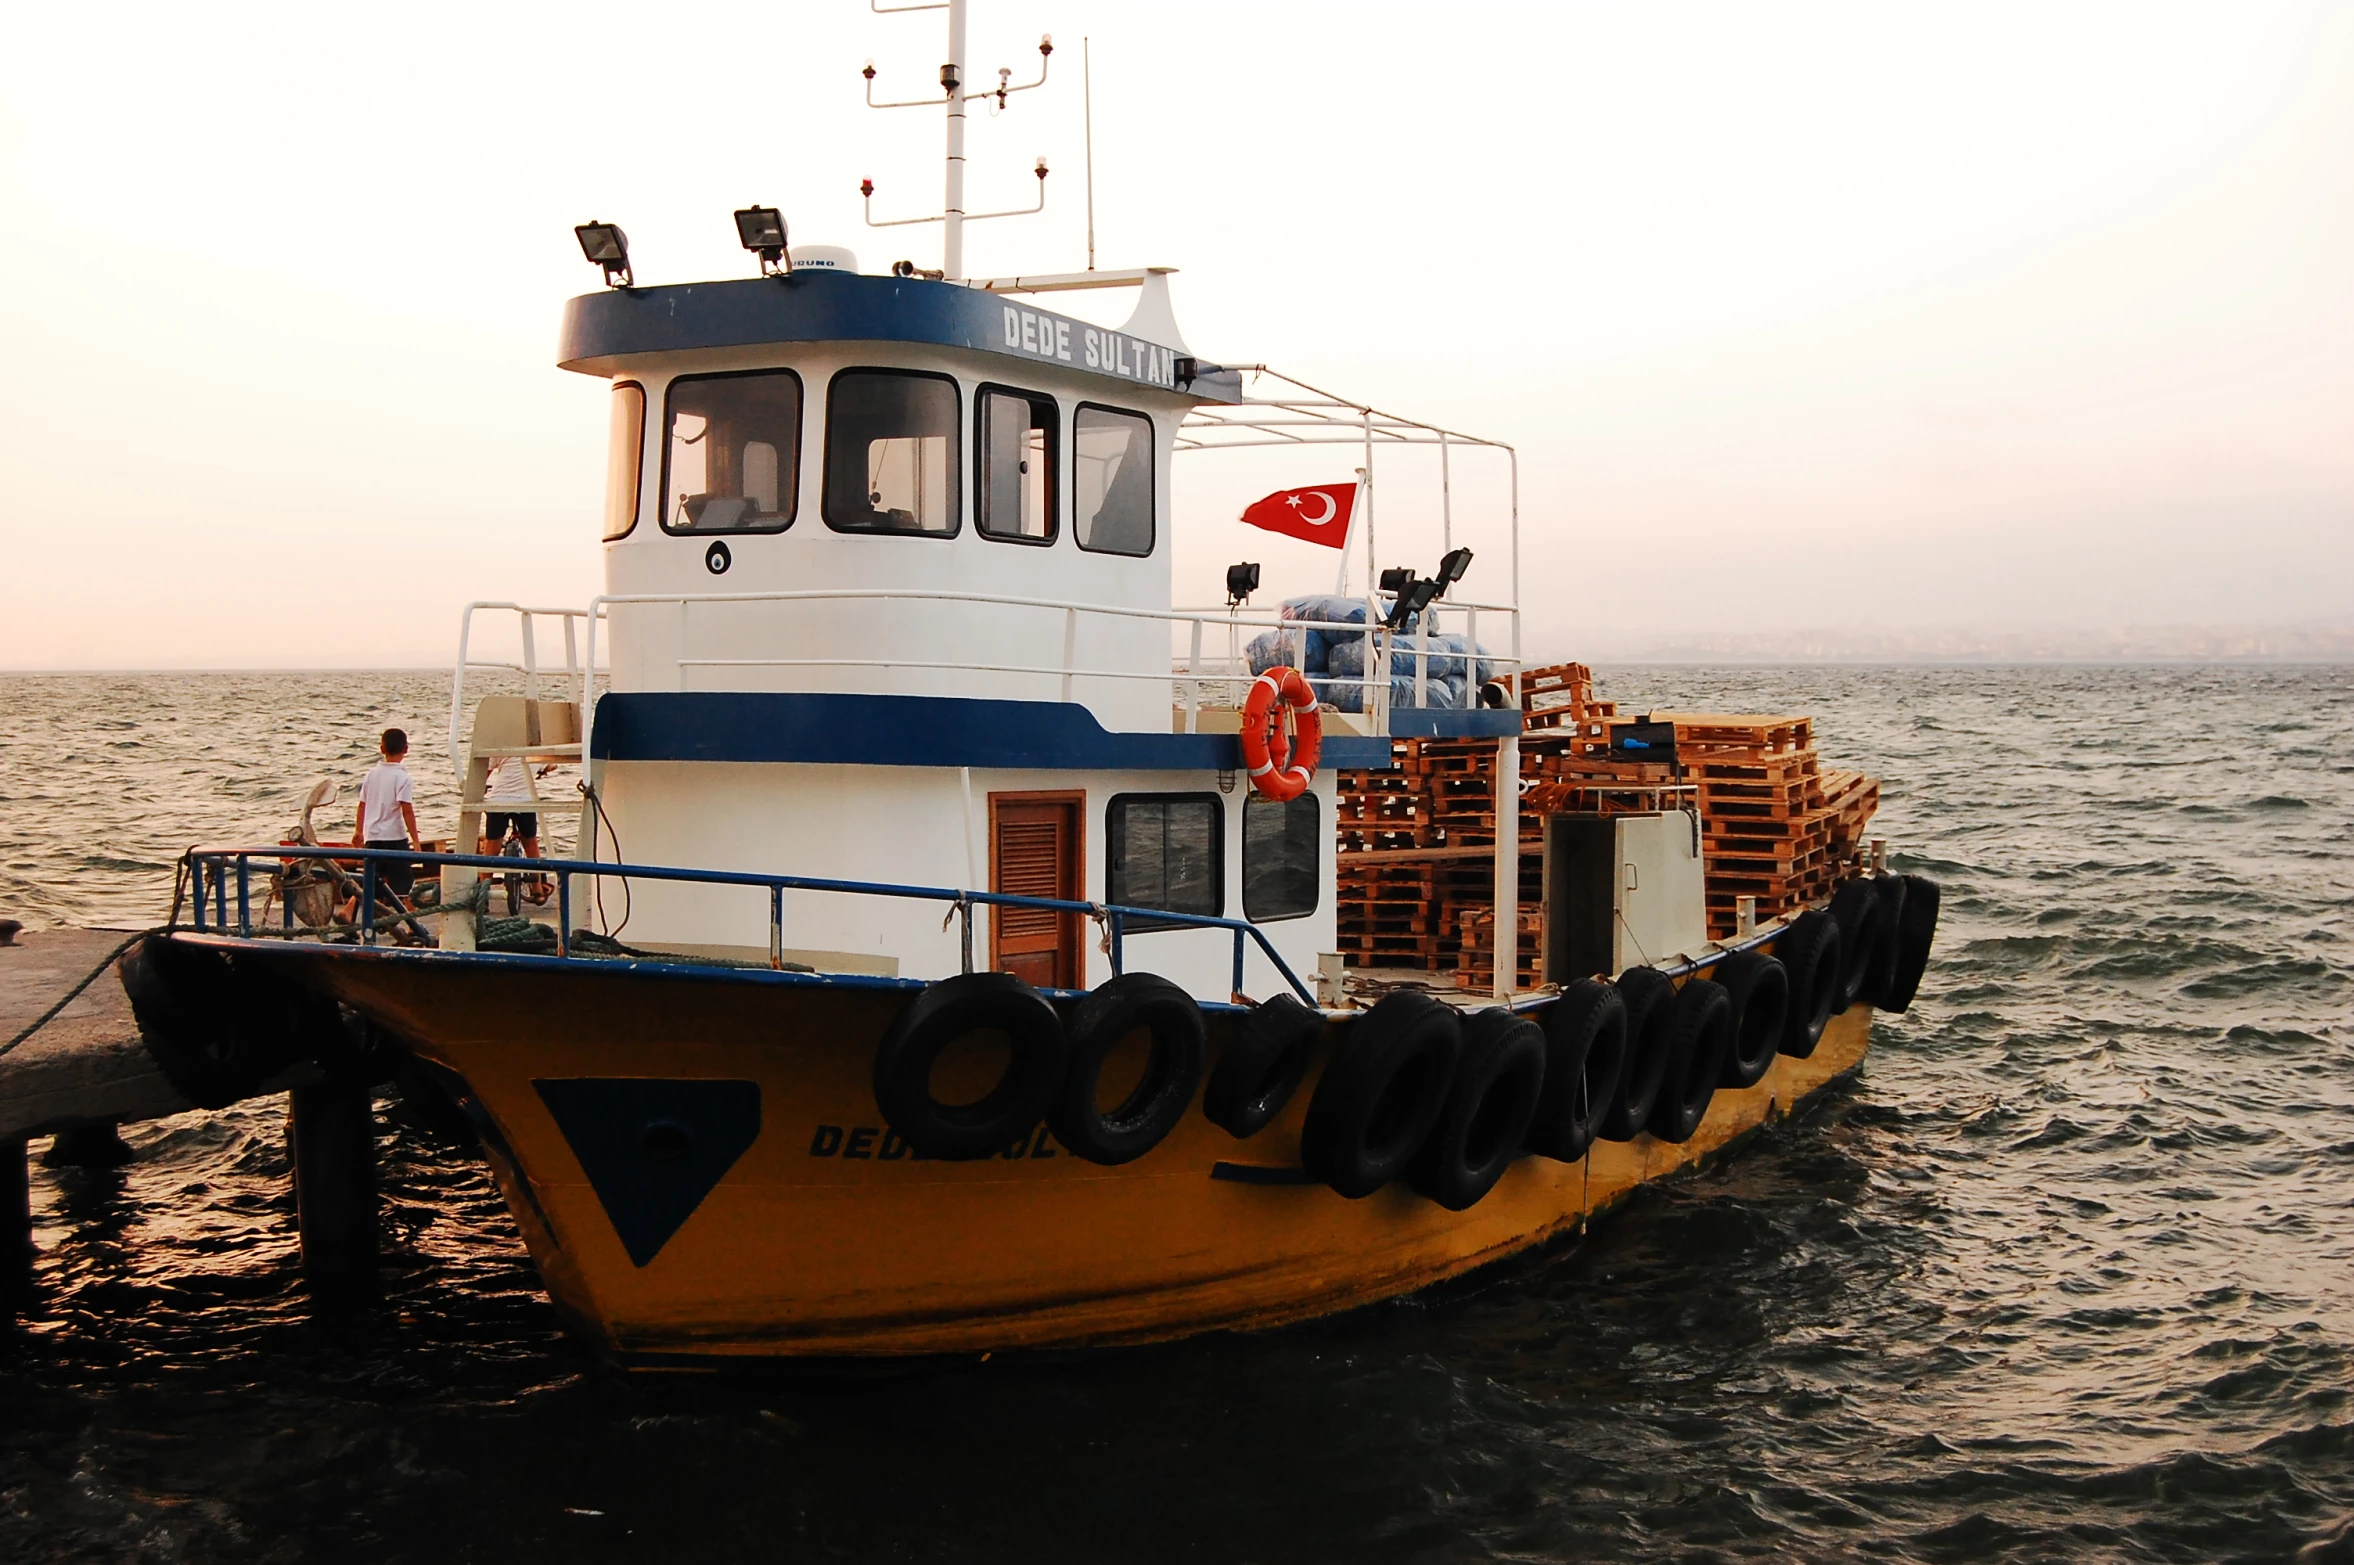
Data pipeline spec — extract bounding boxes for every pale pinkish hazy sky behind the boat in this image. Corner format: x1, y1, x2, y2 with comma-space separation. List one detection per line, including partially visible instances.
0, 0, 2354, 668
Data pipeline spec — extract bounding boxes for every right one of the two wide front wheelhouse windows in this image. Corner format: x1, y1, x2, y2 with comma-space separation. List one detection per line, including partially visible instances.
826, 369, 963, 537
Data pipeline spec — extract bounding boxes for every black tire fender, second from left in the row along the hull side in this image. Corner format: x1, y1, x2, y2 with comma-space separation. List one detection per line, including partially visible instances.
1048, 972, 1208, 1165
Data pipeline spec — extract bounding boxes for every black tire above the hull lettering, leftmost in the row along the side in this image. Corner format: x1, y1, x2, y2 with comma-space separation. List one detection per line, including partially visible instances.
873, 972, 1071, 1160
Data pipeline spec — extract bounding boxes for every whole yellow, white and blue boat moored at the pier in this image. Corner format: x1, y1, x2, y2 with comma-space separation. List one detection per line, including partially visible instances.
125, 0, 1937, 1365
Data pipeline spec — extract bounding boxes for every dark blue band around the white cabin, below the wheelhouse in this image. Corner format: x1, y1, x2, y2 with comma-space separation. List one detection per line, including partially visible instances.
589, 692, 1393, 772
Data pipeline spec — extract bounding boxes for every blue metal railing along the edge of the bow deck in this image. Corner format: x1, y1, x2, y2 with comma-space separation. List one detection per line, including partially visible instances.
186, 843, 1316, 1005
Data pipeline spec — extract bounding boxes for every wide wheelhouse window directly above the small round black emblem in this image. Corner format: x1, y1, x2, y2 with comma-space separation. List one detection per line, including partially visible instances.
661, 369, 800, 534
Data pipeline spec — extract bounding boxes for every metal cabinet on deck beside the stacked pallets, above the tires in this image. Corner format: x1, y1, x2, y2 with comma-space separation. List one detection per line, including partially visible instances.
1544, 810, 1709, 984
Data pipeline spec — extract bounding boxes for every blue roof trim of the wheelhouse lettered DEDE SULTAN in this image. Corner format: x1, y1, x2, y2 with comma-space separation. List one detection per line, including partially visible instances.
556, 271, 1243, 402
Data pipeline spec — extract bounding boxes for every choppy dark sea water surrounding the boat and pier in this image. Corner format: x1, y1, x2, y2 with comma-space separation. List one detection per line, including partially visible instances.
0, 668, 2354, 1563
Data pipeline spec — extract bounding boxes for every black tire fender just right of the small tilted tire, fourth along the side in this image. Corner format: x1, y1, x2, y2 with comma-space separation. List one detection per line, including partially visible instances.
1299, 988, 1462, 1200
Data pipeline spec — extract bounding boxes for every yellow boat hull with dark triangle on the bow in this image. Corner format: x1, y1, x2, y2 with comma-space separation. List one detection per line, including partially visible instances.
284, 958, 1871, 1360
